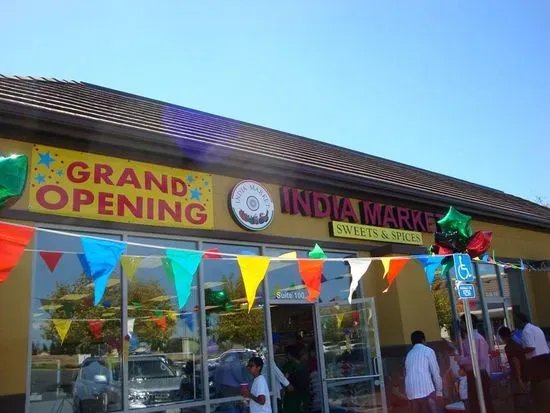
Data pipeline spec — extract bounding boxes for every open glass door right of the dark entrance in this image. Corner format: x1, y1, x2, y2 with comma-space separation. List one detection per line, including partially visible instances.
315, 298, 387, 413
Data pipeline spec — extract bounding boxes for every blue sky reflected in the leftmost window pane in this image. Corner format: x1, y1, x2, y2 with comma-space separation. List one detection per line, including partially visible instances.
31, 231, 121, 341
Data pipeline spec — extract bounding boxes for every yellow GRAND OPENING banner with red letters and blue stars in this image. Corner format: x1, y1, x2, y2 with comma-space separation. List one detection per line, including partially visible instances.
29, 145, 214, 229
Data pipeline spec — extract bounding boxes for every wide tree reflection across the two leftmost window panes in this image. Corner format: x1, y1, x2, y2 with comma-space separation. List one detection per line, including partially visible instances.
42, 274, 175, 354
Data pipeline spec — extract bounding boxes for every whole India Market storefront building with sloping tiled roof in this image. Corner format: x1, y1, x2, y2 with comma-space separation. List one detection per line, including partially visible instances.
0, 77, 550, 413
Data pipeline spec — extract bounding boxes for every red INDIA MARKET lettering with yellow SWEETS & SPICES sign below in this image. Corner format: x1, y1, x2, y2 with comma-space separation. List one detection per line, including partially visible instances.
280, 187, 443, 245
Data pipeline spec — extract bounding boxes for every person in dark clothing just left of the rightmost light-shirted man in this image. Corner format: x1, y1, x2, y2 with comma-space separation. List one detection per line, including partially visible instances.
498, 327, 530, 413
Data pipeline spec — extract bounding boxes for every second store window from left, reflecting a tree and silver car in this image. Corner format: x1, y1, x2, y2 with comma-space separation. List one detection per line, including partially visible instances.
127, 237, 204, 408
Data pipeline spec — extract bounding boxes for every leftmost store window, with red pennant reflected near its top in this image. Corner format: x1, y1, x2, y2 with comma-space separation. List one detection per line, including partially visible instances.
29, 231, 122, 413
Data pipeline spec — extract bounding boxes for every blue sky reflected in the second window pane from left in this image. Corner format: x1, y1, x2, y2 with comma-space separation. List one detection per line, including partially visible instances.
127, 237, 200, 340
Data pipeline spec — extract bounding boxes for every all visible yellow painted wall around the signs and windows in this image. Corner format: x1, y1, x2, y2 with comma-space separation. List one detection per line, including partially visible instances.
0, 138, 550, 394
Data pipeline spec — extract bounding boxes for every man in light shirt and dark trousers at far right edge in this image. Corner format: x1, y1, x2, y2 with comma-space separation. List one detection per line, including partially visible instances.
516, 313, 550, 413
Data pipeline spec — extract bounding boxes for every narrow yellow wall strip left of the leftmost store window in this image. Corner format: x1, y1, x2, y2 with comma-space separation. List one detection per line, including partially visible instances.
0, 222, 32, 396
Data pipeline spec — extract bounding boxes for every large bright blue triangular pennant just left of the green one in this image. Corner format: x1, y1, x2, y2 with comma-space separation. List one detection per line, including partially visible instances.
80, 237, 126, 305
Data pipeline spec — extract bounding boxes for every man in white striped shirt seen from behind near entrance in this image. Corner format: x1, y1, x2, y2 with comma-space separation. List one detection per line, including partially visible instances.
405, 331, 443, 413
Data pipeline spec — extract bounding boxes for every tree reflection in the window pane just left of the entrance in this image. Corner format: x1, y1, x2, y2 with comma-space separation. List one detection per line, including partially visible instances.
207, 273, 265, 349
